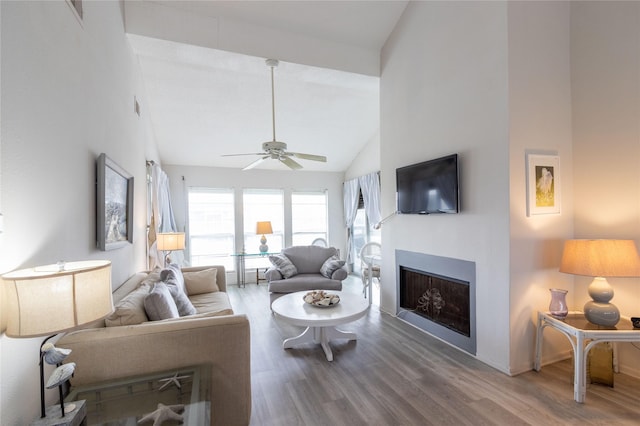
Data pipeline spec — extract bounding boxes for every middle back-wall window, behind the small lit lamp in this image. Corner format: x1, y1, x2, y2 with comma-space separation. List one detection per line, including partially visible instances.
242, 189, 284, 269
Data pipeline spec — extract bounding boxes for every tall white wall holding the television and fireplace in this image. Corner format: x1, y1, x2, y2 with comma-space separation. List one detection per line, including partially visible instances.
380, 2, 510, 372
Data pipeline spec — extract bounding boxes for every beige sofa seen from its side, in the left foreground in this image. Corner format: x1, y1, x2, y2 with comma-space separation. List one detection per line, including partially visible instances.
56, 266, 251, 426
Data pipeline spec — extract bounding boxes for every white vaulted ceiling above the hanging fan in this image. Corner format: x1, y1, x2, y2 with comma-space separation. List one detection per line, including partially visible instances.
125, 1, 407, 171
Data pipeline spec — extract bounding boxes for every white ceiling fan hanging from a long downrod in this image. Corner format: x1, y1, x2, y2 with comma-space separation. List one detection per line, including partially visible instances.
223, 59, 327, 170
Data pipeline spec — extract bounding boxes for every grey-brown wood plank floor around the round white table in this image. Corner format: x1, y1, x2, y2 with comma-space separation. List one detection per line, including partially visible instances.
229, 277, 640, 426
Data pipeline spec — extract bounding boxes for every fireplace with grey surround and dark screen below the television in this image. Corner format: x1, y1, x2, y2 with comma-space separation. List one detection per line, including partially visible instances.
396, 250, 476, 355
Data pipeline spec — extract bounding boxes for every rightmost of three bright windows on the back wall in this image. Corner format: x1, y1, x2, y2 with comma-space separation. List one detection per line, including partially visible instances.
291, 191, 329, 246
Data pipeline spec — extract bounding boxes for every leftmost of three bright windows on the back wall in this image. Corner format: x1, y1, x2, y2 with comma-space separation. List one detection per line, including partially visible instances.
188, 188, 235, 271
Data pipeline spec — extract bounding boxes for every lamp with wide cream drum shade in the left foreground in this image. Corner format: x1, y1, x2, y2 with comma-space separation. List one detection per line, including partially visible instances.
1, 260, 113, 418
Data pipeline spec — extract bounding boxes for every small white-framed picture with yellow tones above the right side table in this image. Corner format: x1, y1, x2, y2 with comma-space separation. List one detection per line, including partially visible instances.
527, 154, 560, 216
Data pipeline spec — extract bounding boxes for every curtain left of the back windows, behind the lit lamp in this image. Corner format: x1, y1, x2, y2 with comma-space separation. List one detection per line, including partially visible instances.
147, 162, 184, 269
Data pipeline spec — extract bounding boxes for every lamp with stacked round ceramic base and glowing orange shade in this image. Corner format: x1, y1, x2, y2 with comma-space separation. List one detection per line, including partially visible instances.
560, 240, 640, 327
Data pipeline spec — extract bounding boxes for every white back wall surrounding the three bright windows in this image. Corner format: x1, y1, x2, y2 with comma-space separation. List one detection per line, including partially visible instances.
162, 164, 346, 270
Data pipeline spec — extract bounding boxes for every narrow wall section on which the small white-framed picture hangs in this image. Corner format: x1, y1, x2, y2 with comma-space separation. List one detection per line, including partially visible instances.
508, 2, 578, 374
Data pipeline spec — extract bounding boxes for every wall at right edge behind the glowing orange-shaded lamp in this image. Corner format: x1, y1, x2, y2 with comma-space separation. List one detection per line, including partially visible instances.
571, 2, 640, 377
